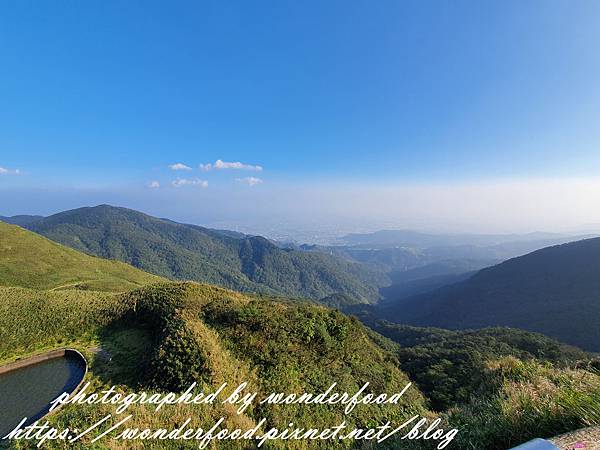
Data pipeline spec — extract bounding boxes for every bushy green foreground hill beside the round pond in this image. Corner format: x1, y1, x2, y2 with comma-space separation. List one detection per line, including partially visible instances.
0, 283, 427, 448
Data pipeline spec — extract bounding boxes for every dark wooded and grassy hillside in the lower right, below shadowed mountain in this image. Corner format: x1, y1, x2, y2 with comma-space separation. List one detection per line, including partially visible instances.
360, 321, 600, 450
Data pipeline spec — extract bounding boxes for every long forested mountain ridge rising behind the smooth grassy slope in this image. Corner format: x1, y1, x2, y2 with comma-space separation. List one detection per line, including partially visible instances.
22, 205, 384, 302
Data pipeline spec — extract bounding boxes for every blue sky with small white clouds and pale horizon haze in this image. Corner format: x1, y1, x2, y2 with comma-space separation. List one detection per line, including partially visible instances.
0, 0, 600, 236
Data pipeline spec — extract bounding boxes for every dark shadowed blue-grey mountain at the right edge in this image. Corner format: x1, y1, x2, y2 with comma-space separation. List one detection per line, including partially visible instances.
380, 238, 600, 351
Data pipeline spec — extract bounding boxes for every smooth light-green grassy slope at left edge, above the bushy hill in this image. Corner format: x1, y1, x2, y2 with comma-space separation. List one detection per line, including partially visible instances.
0, 222, 160, 291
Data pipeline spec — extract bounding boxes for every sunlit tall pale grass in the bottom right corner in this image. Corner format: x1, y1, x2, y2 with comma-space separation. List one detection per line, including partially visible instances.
446, 357, 600, 450
